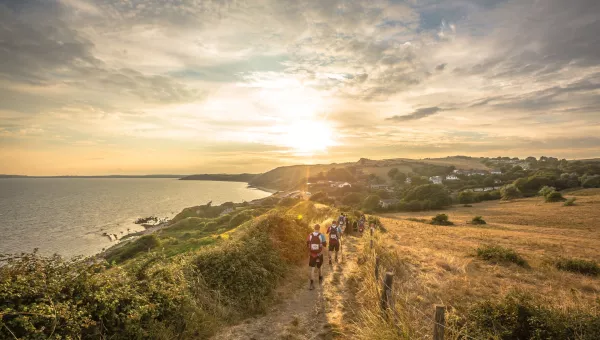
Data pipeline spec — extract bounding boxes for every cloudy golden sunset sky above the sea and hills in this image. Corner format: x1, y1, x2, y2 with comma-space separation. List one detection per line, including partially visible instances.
0, 0, 600, 175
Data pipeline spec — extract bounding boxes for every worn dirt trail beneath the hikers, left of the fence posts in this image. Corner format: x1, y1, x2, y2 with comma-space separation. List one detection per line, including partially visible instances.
213, 236, 358, 340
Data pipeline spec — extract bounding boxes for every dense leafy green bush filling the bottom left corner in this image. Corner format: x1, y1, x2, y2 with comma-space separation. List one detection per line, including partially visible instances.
0, 254, 224, 339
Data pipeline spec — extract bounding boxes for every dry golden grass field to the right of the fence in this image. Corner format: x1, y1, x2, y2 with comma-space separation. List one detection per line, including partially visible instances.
368, 189, 600, 338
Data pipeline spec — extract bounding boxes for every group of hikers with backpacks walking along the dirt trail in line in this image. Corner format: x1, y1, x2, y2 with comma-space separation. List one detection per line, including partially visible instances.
306, 213, 374, 290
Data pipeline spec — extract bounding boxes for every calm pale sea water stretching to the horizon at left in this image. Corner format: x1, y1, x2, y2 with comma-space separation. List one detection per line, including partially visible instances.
0, 178, 270, 257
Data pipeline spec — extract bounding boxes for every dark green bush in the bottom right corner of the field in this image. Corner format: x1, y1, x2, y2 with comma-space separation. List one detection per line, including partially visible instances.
464, 292, 600, 340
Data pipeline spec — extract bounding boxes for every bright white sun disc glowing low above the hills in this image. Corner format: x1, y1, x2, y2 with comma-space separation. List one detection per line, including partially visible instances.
283, 120, 334, 155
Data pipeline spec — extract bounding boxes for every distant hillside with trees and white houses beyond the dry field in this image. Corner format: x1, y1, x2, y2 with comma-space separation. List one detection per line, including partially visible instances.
262, 157, 600, 211
